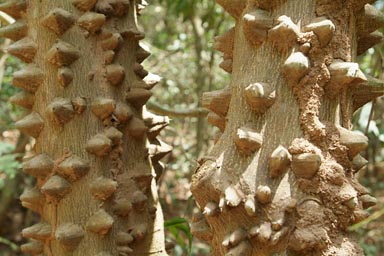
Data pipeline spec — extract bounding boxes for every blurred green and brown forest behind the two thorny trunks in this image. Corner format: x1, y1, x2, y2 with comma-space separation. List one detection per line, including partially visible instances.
0, 0, 384, 256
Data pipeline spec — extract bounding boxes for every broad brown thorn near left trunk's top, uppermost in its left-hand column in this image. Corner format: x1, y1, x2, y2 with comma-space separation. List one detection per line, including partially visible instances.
41, 8, 75, 35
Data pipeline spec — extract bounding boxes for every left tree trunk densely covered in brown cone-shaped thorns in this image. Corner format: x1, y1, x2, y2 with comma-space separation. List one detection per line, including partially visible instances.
0, 0, 170, 256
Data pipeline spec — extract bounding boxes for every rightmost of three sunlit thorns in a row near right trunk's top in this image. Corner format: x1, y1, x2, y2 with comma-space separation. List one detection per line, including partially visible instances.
304, 17, 335, 47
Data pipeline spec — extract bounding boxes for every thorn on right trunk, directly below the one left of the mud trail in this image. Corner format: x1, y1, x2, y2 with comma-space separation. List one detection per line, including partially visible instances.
235, 127, 263, 156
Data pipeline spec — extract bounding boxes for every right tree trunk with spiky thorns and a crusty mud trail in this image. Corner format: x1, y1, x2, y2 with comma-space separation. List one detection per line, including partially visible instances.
192, 0, 384, 255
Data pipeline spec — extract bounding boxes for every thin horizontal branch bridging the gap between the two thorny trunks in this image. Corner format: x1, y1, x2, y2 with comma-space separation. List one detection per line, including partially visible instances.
147, 101, 208, 117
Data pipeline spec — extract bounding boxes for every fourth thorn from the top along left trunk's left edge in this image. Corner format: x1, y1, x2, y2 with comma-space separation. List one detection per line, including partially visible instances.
13, 65, 44, 93
